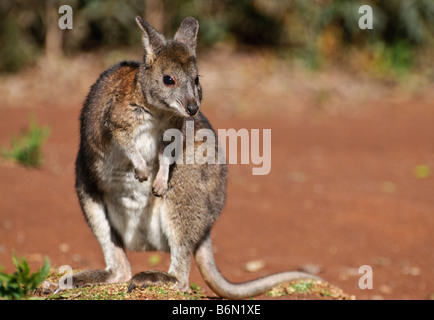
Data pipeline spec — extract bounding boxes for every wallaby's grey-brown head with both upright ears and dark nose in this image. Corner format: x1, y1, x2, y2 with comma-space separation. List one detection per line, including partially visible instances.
136, 17, 202, 117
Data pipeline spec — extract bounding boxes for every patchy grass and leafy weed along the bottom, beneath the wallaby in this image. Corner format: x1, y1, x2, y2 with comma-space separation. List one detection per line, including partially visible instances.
0, 264, 355, 300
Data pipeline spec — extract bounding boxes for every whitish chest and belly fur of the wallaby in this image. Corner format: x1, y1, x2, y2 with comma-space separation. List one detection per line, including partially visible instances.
98, 122, 169, 251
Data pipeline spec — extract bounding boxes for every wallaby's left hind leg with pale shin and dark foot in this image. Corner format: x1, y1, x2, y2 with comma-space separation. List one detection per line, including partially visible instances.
72, 188, 131, 287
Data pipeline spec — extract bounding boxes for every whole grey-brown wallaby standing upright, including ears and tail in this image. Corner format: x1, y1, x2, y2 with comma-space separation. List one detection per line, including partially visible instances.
72, 17, 316, 299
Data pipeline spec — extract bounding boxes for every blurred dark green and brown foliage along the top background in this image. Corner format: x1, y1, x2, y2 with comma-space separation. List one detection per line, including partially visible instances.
0, 0, 434, 72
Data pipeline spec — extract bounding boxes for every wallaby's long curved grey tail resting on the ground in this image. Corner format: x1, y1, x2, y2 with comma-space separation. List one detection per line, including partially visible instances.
194, 233, 320, 299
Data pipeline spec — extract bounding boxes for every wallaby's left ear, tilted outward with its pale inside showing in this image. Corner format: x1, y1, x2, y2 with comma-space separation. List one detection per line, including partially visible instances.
136, 16, 166, 67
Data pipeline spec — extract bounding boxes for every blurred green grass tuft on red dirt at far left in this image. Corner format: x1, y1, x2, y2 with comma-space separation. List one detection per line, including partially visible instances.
1, 118, 50, 168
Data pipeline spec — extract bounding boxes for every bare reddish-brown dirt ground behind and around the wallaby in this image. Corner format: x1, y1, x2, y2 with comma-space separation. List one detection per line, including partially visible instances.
0, 52, 434, 299
